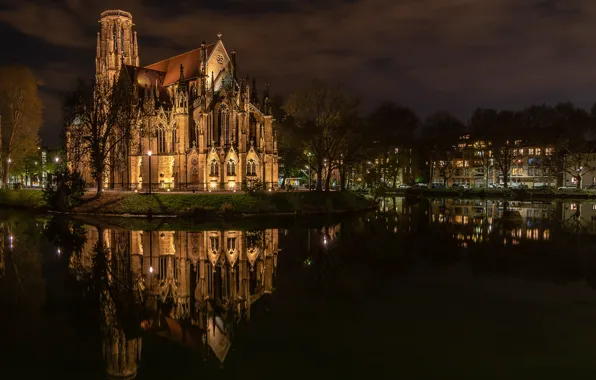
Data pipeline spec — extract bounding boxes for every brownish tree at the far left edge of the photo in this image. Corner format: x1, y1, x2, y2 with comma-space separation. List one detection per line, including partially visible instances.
0, 66, 42, 186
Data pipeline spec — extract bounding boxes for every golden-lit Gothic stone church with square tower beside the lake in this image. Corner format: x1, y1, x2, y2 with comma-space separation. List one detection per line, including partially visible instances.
67, 10, 278, 190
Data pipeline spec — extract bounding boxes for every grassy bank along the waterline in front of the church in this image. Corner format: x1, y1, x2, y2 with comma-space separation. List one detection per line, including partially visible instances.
0, 190, 375, 216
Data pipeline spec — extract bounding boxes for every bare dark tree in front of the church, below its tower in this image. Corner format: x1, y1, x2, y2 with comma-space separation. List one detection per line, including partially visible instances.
64, 70, 141, 196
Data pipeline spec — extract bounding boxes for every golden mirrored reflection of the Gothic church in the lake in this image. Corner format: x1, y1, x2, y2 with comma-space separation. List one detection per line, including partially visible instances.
70, 227, 278, 378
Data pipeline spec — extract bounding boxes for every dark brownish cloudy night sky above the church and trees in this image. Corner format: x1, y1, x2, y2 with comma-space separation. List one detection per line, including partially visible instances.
0, 0, 596, 145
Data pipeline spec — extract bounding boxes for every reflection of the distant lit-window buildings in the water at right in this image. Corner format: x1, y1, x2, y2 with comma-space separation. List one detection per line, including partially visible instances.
376, 198, 596, 248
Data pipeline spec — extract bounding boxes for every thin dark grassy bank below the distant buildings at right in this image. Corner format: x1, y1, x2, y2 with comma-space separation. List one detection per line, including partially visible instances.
378, 188, 596, 201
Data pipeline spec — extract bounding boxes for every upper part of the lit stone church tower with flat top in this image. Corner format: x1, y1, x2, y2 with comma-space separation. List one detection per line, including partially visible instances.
95, 10, 139, 83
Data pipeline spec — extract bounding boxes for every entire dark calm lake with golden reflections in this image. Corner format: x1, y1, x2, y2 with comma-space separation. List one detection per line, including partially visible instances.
0, 198, 596, 379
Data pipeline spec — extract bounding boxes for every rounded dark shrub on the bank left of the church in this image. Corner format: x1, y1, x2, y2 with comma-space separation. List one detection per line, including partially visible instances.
43, 168, 85, 211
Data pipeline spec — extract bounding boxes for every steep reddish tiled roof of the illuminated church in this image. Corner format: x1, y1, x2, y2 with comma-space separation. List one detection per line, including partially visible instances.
146, 43, 217, 86
